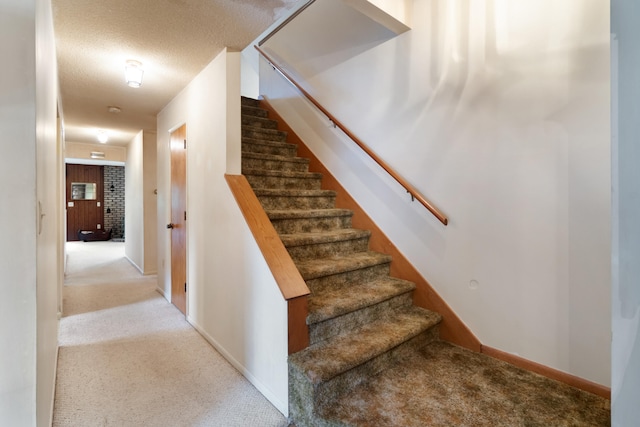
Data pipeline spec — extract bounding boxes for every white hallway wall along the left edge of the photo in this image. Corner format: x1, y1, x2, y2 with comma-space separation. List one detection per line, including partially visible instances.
0, 0, 61, 426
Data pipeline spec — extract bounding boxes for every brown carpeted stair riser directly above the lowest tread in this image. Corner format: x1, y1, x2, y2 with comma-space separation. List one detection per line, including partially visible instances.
309, 292, 413, 345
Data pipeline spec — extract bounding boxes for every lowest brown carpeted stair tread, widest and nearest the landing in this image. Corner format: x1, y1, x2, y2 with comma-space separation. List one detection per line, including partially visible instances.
289, 307, 442, 385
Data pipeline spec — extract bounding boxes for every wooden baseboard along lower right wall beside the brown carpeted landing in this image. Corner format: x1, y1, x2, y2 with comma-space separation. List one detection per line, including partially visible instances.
481, 345, 611, 400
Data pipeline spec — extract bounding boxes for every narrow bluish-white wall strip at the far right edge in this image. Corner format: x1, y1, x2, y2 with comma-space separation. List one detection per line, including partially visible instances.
611, 0, 640, 427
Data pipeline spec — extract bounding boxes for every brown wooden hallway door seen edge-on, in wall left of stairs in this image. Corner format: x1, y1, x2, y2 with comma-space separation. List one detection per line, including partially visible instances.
167, 125, 187, 315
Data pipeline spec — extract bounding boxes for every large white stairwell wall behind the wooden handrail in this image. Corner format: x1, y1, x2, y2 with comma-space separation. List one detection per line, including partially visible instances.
260, 0, 611, 386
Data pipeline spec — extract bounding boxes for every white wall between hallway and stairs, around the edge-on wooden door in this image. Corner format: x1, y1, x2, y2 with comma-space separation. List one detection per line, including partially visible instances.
157, 52, 288, 414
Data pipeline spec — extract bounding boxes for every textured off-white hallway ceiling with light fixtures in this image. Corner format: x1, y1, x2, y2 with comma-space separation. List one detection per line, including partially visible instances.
52, 0, 300, 145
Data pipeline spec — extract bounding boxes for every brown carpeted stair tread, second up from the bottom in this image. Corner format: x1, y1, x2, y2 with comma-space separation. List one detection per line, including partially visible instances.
307, 277, 416, 325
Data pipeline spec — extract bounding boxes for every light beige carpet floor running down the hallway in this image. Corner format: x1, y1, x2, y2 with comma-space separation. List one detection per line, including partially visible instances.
53, 242, 287, 427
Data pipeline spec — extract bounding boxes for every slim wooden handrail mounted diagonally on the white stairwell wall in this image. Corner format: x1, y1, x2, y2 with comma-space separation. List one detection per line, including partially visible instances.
254, 46, 449, 225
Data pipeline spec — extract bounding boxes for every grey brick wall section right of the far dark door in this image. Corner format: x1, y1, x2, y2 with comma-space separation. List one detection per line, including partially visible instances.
104, 166, 124, 238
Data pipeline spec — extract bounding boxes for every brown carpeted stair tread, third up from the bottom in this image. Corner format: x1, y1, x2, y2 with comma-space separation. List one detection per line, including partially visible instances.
296, 251, 391, 280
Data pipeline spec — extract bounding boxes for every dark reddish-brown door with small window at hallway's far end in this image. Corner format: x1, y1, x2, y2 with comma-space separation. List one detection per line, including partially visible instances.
66, 164, 104, 241
